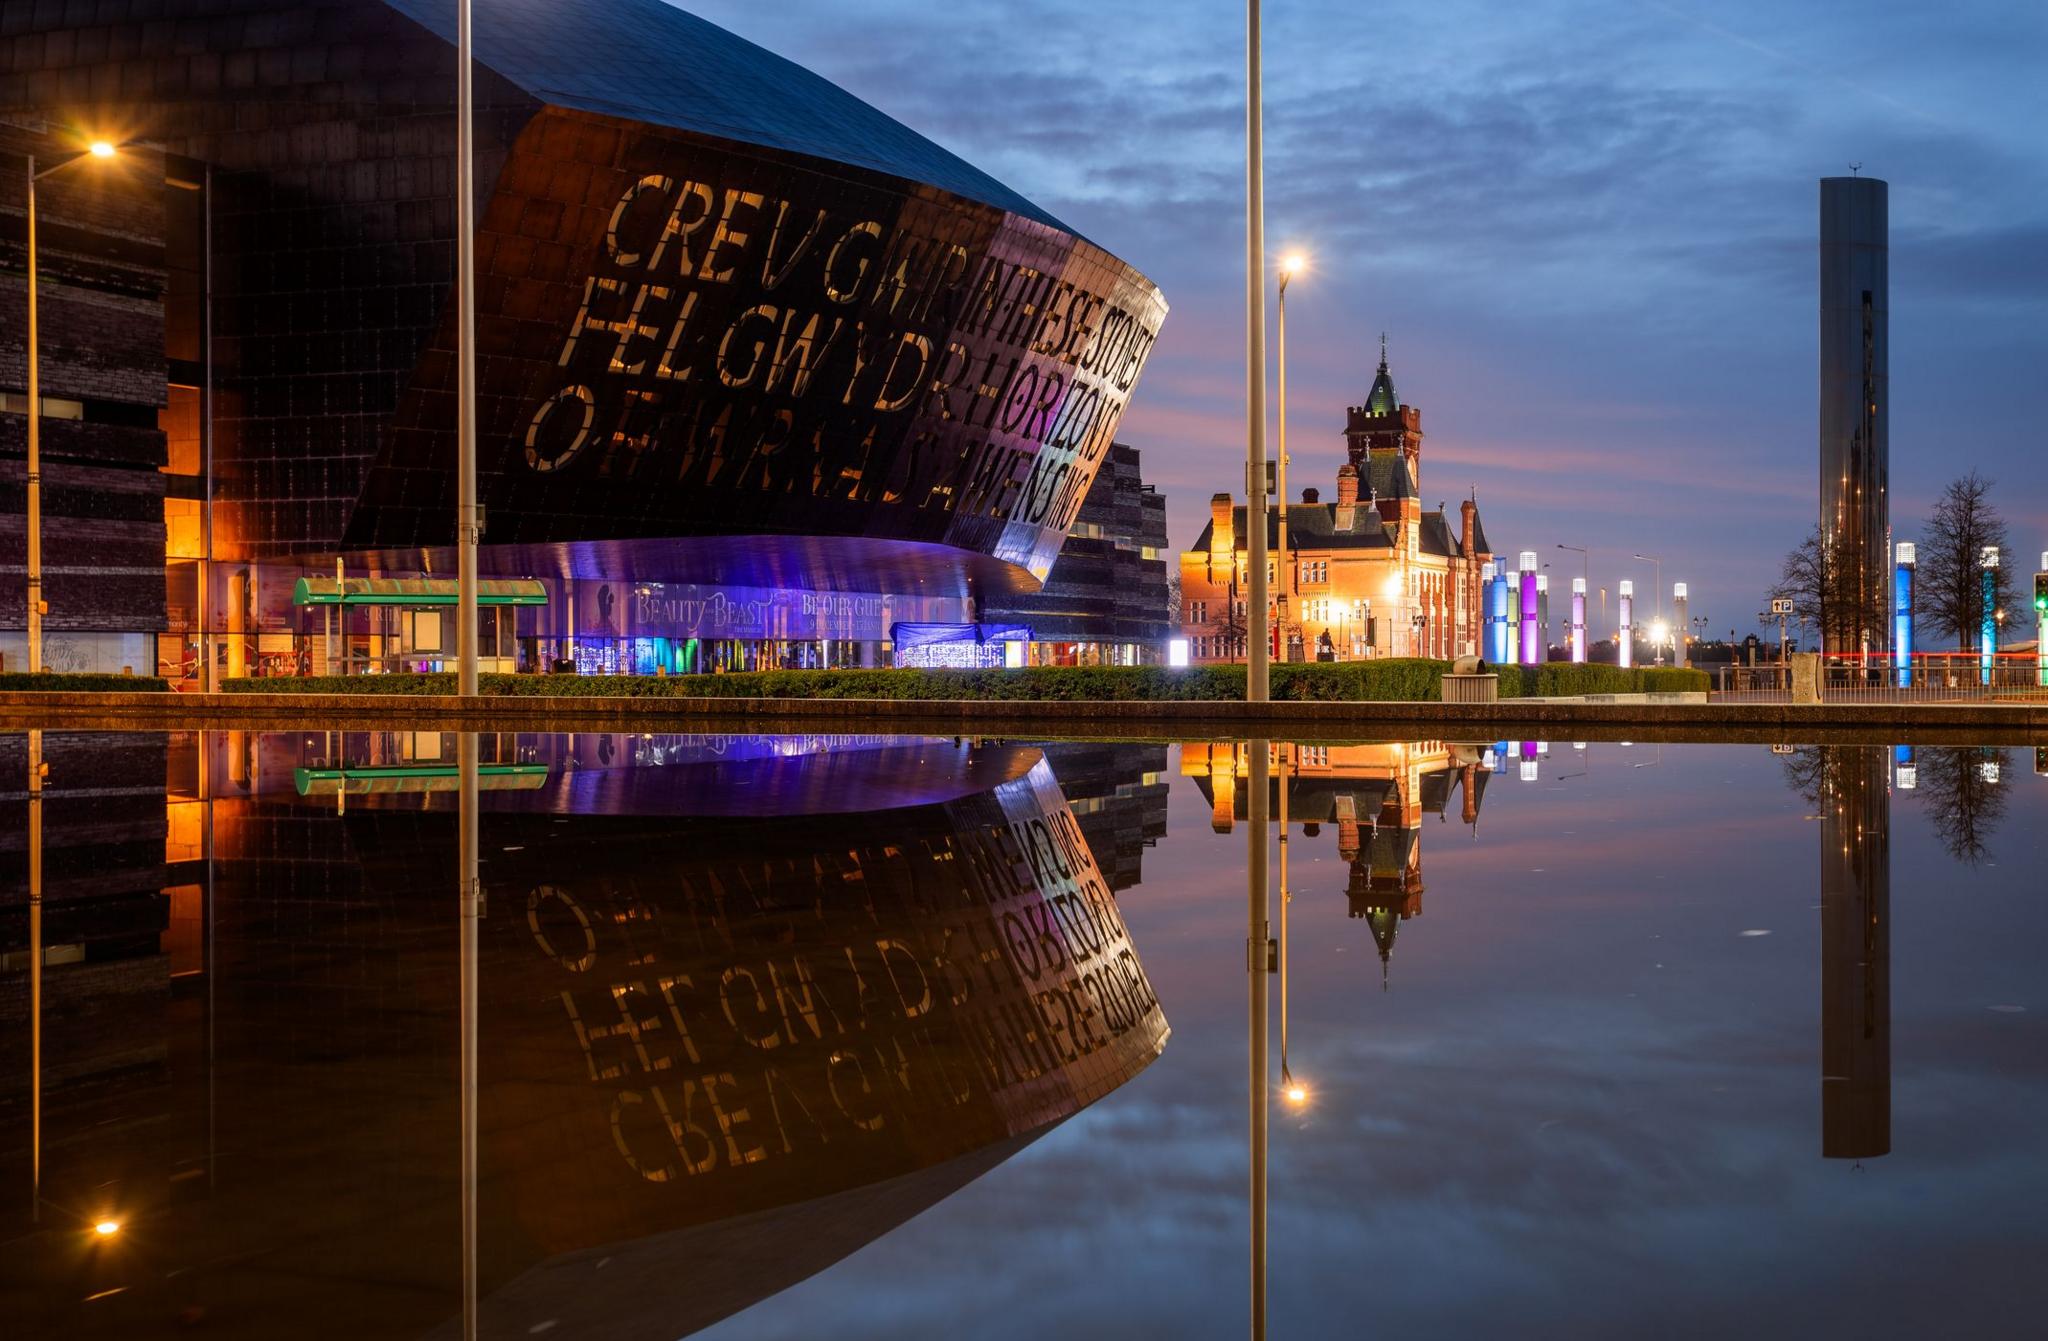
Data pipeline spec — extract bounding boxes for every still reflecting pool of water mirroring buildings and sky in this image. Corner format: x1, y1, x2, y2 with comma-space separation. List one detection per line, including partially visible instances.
0, 731, 2048, 1341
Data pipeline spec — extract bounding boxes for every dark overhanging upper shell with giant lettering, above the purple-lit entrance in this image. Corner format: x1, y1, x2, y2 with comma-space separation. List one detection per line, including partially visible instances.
0, 0, 1165, 593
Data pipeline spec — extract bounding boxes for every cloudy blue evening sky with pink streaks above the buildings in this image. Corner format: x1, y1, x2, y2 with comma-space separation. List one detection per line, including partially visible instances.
686, 0, 2048, 631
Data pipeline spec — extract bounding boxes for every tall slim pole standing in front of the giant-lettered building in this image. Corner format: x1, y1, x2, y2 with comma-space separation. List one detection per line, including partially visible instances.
455, 0, 481, 698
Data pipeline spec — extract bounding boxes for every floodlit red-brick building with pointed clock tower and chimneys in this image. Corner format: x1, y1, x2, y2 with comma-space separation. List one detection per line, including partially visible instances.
1180, 348, 1493, 661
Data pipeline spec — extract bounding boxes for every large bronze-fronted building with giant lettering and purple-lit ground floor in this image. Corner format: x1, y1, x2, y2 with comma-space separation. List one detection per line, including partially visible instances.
0, 0, 1165, 674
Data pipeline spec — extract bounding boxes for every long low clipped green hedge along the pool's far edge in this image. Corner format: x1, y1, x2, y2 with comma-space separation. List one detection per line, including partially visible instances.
221, 657, 1708, 702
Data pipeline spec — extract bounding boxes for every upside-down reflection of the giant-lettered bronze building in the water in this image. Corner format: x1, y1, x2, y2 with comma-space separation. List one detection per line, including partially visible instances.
0, 733, 1167, 1341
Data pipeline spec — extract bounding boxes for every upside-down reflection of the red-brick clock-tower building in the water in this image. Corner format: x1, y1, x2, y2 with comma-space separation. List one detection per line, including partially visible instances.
1180, 741, 1487, 981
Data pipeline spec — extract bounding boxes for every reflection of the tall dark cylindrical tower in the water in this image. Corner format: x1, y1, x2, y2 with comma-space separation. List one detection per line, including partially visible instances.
1821, 745, 1892, 1159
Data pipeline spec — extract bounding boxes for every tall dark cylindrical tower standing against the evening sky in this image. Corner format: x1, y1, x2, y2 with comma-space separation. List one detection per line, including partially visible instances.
1821, 176, 1892, 653
